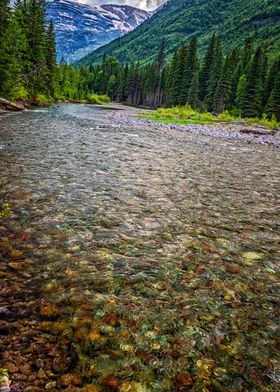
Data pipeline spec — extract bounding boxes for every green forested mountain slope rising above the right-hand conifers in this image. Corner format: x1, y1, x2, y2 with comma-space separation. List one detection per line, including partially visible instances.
76, 0, 280, 65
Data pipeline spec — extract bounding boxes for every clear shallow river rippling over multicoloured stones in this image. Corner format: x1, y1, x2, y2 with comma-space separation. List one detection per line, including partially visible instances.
0, 104, 280, 392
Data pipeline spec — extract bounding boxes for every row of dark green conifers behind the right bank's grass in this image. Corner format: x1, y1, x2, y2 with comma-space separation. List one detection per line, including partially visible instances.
89, 34, 280, 121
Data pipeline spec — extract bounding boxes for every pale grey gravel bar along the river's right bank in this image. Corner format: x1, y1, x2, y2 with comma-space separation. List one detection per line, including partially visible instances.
113, 106, 280, 147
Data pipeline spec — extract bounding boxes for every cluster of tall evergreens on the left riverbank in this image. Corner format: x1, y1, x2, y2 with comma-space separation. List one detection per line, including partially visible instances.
0, 0, 56, 101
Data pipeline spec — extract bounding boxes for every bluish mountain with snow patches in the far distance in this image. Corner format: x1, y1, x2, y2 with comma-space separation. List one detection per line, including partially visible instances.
47, 0, 151, 62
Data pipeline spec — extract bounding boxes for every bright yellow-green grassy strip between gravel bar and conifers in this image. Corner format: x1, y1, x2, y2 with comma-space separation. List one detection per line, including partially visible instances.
141, 105, 280, 129
